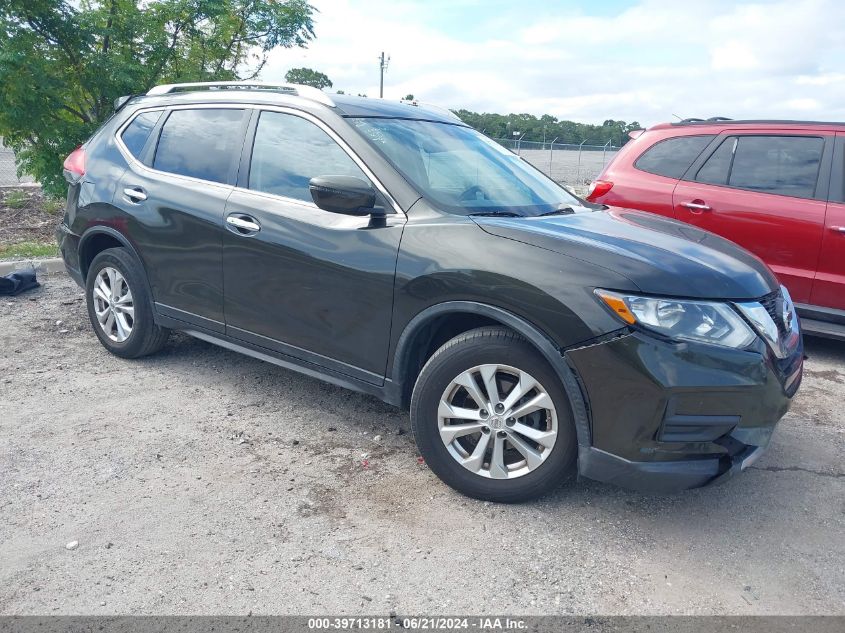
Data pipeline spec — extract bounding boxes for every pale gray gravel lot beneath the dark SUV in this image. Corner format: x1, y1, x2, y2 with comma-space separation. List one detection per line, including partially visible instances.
0, 274, 845, 615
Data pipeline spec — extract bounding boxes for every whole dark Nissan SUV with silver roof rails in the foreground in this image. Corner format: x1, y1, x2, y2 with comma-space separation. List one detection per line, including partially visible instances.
58, 83, 803, 501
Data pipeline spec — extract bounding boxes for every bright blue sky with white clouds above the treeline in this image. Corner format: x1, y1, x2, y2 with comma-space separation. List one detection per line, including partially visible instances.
261, 0, 845, 125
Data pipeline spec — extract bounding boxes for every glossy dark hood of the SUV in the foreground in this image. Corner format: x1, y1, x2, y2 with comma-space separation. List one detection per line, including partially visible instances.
472, 207, 779, 299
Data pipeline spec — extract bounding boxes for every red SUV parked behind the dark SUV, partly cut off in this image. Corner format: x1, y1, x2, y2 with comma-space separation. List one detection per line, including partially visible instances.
587, 117, 845, 339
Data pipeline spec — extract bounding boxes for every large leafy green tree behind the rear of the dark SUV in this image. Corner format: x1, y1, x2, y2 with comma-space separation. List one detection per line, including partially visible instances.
0, 0, 314, 193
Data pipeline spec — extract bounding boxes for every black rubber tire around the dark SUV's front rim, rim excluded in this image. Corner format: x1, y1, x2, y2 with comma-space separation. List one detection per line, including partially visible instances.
411, 327, 578, 503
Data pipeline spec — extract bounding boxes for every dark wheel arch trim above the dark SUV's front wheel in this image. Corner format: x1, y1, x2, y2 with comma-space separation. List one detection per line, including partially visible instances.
390, 301, 590, 447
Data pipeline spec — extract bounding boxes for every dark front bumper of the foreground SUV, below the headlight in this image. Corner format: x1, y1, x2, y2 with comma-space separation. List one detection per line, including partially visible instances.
566, 331, 804, 492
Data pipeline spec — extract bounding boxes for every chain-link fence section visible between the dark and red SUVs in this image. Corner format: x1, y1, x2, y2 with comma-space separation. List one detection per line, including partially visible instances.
493, 138, 619, 192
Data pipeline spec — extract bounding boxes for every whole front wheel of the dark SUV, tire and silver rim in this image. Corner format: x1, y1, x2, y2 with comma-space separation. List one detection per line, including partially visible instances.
411, 327, 577, 503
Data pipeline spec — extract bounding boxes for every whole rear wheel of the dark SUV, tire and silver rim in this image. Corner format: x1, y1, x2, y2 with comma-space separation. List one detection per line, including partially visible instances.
85, 248, 170, 358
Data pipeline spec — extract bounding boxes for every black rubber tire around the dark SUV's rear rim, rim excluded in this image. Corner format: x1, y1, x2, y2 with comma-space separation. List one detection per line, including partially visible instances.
85, 248, 170, 358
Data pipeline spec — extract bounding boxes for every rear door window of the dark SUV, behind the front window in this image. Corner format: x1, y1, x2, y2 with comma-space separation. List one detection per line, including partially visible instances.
153, 108, 244, 183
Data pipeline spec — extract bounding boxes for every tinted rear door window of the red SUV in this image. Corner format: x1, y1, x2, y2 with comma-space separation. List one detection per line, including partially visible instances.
728, 136, 824, 198
